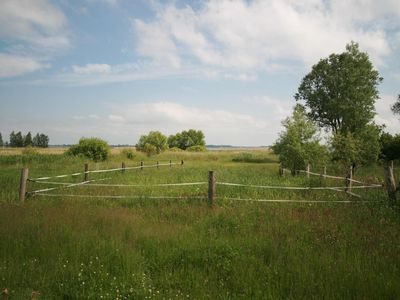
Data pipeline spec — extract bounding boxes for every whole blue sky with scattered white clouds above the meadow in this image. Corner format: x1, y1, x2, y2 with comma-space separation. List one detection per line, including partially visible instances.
0, 0, 400, 146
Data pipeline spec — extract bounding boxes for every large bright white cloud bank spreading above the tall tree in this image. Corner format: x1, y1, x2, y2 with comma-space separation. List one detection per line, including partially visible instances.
134, 0, 400, 70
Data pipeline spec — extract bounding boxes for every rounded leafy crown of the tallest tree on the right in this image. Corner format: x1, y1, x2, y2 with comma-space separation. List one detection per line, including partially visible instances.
295, 42, 382, 134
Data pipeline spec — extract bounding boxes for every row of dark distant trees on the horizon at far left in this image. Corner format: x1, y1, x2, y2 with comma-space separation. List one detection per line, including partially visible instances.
0, 131, 49, 148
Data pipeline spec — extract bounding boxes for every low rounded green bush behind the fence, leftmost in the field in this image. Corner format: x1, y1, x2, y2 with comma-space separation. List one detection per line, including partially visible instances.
66, 138, 110, 161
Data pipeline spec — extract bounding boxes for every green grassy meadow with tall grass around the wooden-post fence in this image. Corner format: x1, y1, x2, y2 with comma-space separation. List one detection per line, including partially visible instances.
0, 151, 400, 299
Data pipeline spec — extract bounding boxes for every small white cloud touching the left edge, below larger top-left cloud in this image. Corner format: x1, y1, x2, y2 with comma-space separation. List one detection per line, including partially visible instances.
0, 53, 46, 78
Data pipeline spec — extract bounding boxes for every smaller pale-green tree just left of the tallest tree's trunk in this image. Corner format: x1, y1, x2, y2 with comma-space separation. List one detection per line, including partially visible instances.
272, 105, 327, 174
